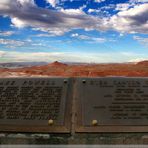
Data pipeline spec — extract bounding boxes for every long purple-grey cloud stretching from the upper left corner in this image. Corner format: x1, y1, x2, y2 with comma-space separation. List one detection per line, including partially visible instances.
0, 0, 107, 35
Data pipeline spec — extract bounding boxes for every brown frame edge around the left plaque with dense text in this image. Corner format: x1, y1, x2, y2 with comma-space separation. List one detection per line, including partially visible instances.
0, 77, 73, 133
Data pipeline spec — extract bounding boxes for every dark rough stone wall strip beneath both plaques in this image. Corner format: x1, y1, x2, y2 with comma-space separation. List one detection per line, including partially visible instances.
0, 133, 148, 144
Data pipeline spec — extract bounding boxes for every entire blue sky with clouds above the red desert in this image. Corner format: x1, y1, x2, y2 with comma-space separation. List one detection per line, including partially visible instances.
0, 0, 148, 63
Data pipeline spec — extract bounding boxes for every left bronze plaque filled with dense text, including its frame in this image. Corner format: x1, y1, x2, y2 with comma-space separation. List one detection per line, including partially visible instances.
0, 78, 72, 132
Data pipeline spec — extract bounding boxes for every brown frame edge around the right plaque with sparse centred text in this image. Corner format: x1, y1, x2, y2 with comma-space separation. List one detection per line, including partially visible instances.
74, 77, 148, 133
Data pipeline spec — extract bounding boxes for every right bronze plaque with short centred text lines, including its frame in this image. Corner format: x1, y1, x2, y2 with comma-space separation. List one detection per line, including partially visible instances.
76, 77, 148, 132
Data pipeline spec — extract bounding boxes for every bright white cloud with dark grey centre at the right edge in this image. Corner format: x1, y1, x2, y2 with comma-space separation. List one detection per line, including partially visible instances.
108, 3, 148, 33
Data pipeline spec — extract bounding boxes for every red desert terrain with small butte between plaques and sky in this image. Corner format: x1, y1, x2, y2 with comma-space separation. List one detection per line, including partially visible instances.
0, 61, 148, 77
